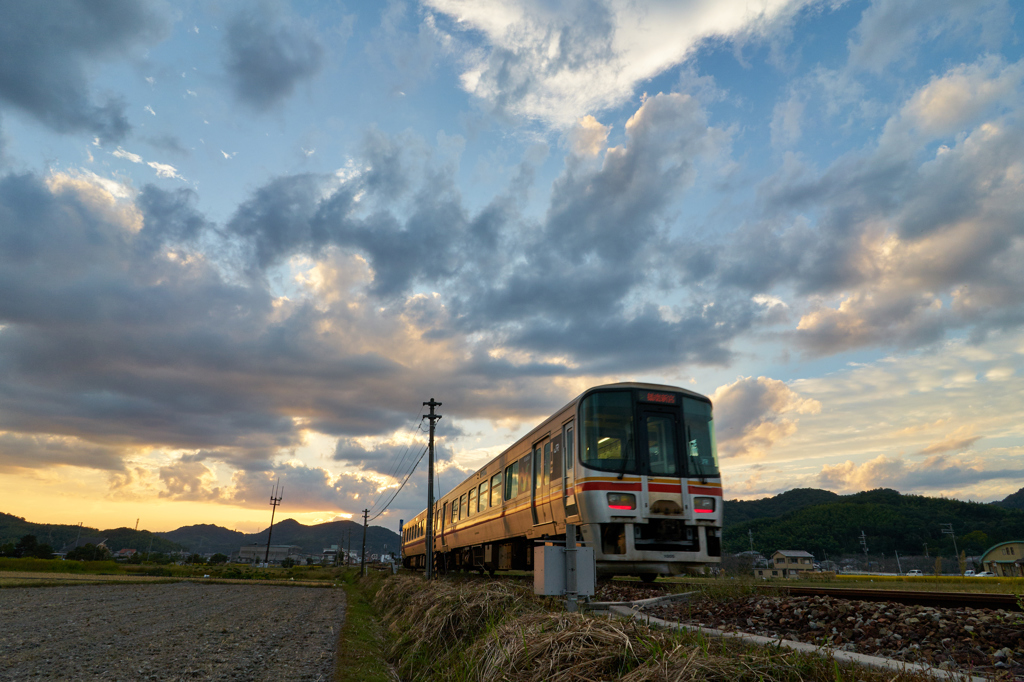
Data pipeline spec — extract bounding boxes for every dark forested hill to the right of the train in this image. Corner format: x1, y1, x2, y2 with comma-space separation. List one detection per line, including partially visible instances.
723, 488, 1024, 557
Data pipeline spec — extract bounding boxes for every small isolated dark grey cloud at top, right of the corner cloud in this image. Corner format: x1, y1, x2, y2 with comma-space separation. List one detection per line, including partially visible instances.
225, 2, 324, 112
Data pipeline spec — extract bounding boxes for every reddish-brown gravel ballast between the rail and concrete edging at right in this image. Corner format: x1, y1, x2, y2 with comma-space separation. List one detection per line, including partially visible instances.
644, 596, 1024, 680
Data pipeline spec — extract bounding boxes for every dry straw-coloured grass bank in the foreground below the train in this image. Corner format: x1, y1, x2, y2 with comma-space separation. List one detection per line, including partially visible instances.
375, 577, 942, 682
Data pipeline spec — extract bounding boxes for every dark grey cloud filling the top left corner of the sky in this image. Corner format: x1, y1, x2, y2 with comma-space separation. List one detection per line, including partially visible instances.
0, 0, 168, 141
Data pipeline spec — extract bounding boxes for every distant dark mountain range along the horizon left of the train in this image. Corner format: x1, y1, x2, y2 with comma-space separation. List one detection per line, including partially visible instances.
0, 512, 398, 555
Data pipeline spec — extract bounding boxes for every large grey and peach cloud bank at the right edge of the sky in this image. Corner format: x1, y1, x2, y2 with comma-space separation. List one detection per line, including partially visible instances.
711, 57, 1024, 355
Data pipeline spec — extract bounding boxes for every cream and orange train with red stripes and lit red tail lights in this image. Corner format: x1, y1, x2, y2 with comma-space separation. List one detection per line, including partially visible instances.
401, 383, 722, 581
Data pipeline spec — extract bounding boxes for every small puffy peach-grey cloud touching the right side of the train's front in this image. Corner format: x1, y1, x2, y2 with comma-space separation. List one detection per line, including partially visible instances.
711, 377, 821, 458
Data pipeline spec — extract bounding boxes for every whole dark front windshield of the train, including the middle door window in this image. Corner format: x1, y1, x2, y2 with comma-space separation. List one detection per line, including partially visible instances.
580, 390, 719, 477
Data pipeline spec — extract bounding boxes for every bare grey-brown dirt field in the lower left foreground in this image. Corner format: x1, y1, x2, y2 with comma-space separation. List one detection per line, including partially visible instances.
0, 583, 345, 681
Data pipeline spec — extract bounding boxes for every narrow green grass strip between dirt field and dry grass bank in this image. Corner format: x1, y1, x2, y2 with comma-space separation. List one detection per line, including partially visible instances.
334, 569, 396, 682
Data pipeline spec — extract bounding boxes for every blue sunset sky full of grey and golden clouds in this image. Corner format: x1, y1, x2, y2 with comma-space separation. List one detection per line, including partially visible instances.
0, 0, 1024, 531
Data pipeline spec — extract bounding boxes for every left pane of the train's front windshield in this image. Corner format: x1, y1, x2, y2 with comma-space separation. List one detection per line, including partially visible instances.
580, 391, 638, 473
